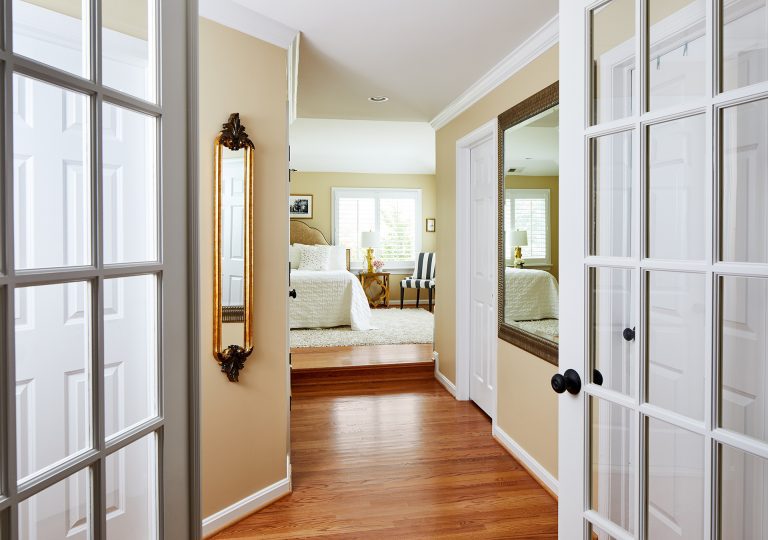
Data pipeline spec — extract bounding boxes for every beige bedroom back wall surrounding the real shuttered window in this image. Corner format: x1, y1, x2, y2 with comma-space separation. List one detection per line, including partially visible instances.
291, 172, 442, 302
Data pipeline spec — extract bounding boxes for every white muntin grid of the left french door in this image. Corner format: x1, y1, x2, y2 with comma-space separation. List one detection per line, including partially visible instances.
0, 0, 164, 540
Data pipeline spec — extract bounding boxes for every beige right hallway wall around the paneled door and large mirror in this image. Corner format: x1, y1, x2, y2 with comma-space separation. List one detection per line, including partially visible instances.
435, 46, 558, 475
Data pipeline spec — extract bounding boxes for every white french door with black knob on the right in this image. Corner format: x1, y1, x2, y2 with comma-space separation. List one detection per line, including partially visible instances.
553, 0, 768, 540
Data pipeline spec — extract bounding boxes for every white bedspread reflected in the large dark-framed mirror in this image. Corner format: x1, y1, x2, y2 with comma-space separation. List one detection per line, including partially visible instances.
504, 268, 559, 321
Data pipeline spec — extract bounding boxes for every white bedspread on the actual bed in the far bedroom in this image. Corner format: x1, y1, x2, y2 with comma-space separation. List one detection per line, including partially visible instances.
288, 270, 371, 330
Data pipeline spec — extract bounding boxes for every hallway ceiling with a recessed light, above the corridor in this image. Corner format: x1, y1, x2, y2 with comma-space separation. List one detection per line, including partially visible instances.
230, 0, 558, 122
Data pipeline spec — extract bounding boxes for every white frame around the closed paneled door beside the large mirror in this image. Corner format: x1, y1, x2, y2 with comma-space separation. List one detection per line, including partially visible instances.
456, 117, 499, 418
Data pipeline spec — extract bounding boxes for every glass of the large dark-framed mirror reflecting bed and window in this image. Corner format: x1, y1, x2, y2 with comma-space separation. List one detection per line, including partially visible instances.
503, 106, 559, 343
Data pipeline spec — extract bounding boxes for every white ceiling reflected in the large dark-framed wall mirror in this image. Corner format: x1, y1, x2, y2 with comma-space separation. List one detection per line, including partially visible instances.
504, 107, 560, 176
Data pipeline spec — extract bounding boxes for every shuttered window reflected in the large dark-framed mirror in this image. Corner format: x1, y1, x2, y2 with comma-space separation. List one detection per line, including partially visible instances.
504, 189, 551, 266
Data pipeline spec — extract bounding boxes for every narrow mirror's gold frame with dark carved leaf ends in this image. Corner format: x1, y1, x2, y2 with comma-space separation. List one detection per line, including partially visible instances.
213, 113, 254, 382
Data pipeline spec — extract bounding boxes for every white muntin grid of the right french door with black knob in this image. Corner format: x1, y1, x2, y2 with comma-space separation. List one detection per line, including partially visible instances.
584, 0, 768, 538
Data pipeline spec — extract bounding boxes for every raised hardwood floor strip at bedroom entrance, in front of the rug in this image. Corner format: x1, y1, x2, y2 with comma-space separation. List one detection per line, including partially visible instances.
291, 343, 432, 370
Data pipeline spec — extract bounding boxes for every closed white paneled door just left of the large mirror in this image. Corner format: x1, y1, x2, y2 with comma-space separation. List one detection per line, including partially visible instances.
469, 132, 498, 418
